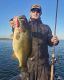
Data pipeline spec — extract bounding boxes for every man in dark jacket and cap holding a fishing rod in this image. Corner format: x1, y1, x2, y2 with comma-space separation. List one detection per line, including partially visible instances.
28, 4, 59, 80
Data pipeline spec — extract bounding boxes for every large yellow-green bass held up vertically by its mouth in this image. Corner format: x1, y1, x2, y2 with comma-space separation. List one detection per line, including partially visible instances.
12, 16, 32, 68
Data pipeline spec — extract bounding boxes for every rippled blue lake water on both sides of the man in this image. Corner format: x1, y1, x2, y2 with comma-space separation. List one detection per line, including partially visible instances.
0, 40, 64, 80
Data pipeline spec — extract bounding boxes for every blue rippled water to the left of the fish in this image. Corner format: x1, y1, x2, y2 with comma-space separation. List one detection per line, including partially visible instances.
0, 40, 19, 80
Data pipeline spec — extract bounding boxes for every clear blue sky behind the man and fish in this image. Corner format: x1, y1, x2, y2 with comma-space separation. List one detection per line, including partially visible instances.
0, 0, 64, 39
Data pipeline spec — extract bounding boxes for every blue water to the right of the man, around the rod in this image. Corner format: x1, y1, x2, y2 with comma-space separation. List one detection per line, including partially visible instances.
49, 40, 64, 80
